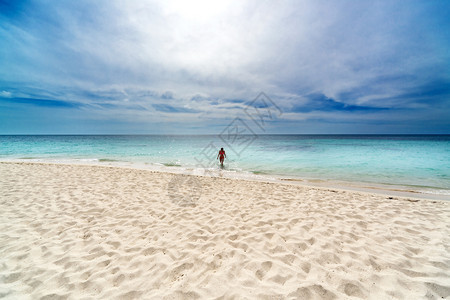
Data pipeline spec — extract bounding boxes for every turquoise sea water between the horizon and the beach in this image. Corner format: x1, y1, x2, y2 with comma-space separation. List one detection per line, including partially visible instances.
0, 135, 450, 194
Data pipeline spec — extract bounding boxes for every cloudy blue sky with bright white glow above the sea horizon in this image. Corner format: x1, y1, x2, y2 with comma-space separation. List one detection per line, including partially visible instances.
0, 0, 450, 134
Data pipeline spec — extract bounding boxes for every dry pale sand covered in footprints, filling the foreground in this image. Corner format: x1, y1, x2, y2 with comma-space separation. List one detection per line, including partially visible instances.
0, 163, 450, 299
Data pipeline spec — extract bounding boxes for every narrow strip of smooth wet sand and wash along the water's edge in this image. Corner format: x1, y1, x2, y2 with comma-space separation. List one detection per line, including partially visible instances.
0, 159, 450, 201
